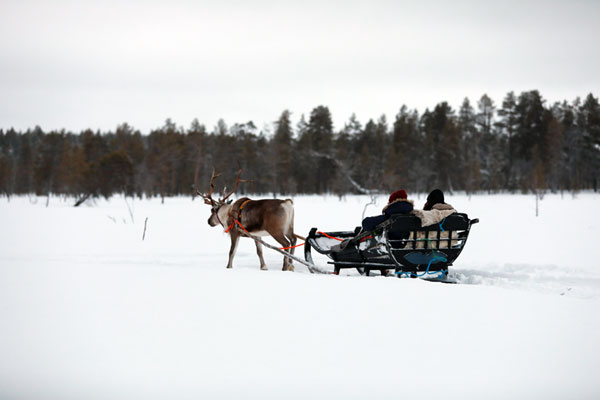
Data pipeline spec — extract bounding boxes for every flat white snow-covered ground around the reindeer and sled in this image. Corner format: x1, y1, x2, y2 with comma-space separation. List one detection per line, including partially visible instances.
0, 193, 600, 400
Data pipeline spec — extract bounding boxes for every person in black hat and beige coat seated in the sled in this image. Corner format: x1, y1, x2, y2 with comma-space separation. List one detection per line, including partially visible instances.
410, 189, 458, 249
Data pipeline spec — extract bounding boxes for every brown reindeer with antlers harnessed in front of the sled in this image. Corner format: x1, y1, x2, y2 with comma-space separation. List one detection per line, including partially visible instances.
198, 168, 301, 271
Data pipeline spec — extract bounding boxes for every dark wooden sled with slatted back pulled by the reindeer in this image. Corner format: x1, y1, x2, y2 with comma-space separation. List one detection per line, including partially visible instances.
304, 213, 479, 280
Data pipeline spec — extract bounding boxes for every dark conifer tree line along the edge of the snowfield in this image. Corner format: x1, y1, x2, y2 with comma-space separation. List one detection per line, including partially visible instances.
0, 90, 600, 203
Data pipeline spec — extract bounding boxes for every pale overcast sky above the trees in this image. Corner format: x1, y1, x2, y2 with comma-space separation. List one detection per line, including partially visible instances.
0, 0, 600, 133
